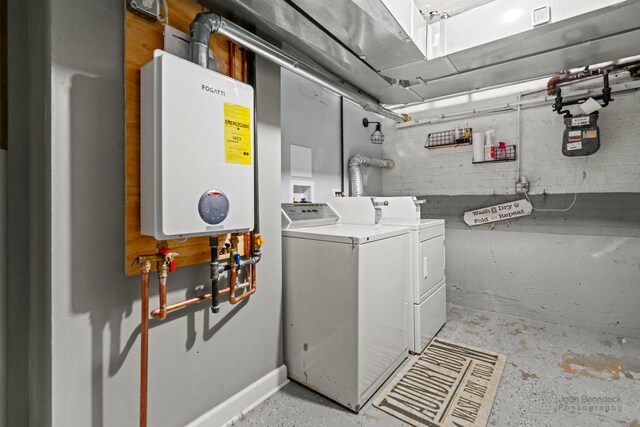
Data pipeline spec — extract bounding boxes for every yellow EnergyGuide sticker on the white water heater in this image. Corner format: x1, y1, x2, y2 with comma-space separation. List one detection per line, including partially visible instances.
224, 102, 251, 165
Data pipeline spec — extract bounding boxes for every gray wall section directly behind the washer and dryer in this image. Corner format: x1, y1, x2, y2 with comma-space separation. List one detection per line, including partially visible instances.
281, 70, 382, 203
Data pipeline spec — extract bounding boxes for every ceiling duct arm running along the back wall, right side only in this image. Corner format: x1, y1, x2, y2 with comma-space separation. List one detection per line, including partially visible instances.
382, 0, 640, 99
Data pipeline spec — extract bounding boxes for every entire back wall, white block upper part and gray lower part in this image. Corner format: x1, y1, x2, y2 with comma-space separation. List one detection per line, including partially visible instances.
383, 81, 640, 337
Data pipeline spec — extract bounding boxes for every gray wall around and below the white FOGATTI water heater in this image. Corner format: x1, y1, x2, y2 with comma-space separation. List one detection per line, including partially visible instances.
9, 0, 282, 426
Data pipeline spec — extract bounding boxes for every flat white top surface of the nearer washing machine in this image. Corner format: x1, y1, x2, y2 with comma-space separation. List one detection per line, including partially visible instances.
282, 224, 407, 245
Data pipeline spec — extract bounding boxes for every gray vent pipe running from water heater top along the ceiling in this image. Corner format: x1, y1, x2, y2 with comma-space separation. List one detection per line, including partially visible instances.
190, 12, 405, 123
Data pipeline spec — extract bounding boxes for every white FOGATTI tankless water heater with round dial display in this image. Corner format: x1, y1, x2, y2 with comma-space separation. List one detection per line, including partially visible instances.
140, 51, 254, 240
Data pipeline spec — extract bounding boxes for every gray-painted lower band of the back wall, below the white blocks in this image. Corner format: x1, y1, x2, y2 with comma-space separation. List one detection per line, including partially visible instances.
422, 193, 640, 337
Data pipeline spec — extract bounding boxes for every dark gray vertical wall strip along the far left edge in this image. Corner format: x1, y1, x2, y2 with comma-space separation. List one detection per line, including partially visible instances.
6, 0, 51, 426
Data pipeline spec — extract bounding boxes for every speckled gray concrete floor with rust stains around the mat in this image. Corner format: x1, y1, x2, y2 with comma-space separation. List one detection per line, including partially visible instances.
239, 305, 640, 427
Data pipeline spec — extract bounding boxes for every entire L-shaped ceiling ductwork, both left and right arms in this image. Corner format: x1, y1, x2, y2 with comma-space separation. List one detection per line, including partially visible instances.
198, 0, 640, 104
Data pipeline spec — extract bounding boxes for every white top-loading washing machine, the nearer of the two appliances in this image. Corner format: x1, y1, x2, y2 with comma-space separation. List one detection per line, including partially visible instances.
282, 204, 409, 412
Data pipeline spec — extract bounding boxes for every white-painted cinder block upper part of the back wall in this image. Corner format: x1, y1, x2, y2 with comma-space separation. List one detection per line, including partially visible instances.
383, 88, 640, 195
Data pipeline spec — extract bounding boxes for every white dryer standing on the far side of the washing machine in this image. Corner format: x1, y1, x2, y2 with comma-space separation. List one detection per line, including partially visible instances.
373, 197, 447, 353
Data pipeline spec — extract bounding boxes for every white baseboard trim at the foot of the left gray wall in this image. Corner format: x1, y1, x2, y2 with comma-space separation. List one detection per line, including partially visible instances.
187, 365, 289, 427
